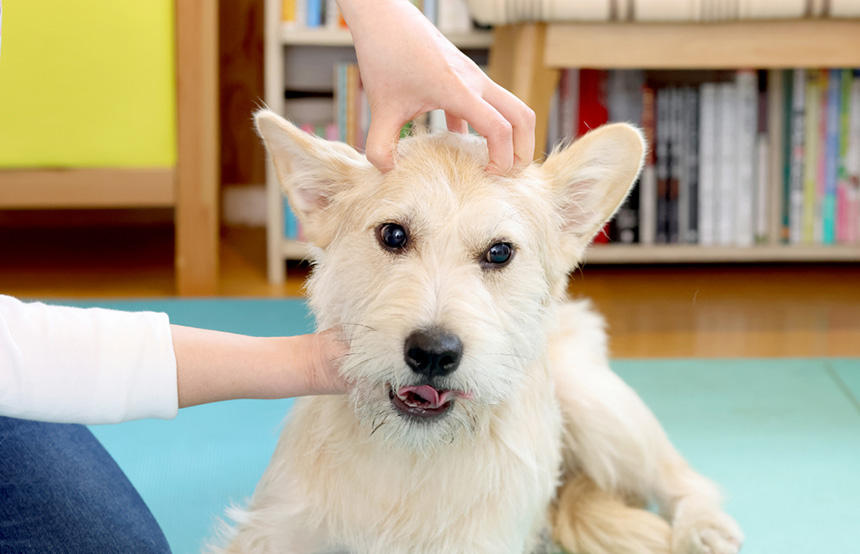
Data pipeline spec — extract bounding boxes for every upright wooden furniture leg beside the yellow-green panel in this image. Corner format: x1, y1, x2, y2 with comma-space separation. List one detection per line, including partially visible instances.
175, 0, 219, 296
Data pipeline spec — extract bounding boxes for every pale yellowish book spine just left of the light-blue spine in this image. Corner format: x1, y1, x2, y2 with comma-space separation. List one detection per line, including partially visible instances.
801, 71, 821, 244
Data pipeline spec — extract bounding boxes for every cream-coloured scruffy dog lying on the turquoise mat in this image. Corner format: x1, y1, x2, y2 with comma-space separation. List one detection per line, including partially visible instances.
220, 111, 742, 554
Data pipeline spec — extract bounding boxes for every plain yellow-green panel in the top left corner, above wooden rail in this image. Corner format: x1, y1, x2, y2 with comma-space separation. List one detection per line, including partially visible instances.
0, 0, 176, 168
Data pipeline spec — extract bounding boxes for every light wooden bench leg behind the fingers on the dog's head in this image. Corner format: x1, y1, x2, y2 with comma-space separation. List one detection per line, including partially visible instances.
490, 23, 561, 158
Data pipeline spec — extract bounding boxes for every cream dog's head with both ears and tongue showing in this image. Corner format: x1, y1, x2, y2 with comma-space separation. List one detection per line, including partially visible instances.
256, 111, 644, 449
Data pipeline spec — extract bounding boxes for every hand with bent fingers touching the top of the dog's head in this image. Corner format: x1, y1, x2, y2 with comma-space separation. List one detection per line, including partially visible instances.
339, 0, 535, 174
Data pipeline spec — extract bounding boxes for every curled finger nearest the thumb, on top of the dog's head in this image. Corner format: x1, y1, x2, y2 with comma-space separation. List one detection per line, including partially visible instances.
445, 93, 514, 175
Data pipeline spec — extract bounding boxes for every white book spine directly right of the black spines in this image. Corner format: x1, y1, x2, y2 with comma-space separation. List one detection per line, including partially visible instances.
698, 83, 717, 246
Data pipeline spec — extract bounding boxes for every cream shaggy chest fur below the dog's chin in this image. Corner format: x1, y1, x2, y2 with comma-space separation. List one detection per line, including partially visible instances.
264, 360, 561, 554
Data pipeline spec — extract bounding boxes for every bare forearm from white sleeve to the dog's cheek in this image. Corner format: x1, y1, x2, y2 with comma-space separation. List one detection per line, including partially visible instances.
171, 325, 345, 408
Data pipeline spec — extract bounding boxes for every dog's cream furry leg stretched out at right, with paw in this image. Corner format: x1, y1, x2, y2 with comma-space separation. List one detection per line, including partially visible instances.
552, 326, 743, 554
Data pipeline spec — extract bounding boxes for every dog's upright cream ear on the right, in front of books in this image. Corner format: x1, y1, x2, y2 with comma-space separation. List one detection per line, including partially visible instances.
541, 123, 645, 247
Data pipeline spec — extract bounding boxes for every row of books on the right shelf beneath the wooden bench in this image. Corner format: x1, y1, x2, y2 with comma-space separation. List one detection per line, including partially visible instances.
547, 69, 860, 246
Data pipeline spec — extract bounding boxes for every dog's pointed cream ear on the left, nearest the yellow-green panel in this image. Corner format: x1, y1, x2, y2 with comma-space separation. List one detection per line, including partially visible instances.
254, 110, 373, 246
